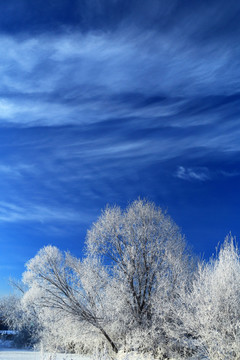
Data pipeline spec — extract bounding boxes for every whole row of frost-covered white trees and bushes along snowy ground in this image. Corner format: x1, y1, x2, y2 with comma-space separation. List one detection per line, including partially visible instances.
0, 200, 240, 360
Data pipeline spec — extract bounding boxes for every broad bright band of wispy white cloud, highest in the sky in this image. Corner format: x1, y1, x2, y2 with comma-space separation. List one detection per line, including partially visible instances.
0, 26, 240, 126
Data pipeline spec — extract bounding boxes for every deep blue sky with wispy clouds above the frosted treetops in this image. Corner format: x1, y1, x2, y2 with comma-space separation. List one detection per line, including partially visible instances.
0, 0, 240, 293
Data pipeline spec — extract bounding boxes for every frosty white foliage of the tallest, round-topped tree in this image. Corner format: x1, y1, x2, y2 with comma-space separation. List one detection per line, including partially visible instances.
87, 200, 187, 334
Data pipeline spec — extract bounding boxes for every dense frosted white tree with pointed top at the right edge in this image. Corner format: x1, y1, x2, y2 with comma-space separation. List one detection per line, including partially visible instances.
184, 235, 240, 360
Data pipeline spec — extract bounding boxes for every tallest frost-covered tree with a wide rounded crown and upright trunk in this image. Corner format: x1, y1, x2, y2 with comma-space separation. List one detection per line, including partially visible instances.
87, 200, 190, 352
